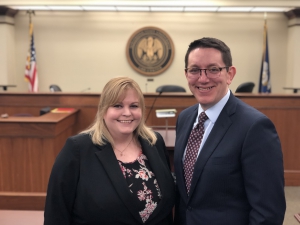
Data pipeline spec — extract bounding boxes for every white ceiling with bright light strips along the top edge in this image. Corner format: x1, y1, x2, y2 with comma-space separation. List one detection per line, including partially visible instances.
0, 0, 300, 12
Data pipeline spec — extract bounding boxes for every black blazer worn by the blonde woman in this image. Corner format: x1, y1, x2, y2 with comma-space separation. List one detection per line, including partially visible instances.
44, 134, 175, 225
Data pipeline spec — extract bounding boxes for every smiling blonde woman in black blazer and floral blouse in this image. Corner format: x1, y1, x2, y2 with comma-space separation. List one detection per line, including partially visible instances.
44, 77, 175, 225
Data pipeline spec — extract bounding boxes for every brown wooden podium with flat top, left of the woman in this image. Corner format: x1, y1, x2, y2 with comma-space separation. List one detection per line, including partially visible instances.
0, 110, 78, 210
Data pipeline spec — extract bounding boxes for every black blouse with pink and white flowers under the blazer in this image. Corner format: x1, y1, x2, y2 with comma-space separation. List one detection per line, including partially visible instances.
118, 152, 161, 223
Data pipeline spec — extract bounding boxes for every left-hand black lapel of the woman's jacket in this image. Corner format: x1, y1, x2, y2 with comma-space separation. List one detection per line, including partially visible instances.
95, 144, 143, 223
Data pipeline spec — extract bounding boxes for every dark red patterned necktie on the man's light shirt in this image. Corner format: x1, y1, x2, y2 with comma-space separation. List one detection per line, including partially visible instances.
183, 112, 208, 193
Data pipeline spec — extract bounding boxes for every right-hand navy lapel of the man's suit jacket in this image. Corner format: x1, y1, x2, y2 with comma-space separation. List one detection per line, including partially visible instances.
188, 94, 236, 200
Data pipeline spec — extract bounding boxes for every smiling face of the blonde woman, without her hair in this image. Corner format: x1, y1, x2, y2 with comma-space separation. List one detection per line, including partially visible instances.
104, 89, 142, 139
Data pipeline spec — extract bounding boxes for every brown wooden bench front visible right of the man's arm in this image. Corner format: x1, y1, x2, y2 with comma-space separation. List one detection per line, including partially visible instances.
242, 95, 300, 186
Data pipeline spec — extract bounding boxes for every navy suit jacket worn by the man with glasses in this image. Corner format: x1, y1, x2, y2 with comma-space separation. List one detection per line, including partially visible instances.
174, 93, 286, 225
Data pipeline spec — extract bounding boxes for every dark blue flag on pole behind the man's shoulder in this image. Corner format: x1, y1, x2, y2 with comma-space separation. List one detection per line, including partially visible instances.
258, 19, 271, 93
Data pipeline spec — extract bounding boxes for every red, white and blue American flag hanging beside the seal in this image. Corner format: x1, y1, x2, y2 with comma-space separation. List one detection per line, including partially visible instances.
25, 22, 38, 92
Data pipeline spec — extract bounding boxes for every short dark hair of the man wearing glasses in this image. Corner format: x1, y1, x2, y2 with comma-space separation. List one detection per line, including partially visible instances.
184, 37, 232, 68
